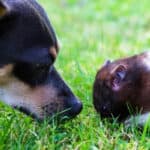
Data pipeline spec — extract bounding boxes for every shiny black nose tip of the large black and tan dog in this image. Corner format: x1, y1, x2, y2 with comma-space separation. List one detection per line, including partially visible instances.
68, 100, 83, 118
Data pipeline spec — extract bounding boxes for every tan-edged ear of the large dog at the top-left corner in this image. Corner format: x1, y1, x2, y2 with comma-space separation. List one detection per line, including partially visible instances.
0, 0, 9, 18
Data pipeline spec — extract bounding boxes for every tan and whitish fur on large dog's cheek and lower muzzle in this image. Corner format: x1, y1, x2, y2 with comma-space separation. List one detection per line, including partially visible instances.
0, 65, 64, 119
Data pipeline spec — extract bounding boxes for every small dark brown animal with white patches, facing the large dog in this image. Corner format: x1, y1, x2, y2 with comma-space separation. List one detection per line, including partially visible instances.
93, 52, 150, 126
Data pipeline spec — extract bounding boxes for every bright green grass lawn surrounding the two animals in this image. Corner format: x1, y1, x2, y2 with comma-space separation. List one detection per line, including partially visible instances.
0, 0, 150, 150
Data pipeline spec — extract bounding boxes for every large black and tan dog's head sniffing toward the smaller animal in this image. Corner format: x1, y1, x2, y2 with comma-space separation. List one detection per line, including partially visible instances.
0, 0, 82, 120
